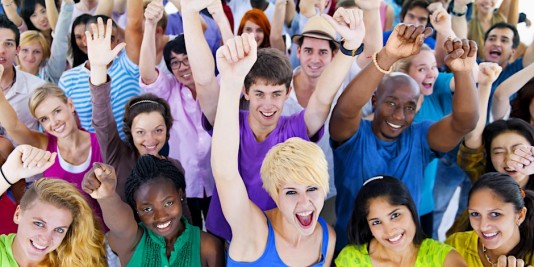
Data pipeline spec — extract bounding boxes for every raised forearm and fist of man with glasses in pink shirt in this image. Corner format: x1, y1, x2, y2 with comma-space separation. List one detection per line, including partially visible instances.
139, 0, 165, 84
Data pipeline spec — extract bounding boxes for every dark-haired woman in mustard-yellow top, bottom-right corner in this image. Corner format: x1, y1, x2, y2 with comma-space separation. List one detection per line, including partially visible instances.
445, 173, 534, 267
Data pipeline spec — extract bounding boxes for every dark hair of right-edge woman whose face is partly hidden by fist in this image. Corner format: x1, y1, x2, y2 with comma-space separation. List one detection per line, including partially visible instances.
482, 118, 534, 190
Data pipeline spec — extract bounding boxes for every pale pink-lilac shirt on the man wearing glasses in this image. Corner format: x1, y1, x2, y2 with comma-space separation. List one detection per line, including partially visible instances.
139, 68, 215, 198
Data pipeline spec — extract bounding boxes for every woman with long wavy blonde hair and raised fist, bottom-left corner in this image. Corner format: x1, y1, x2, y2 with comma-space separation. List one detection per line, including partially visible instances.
0, 145, 107, 267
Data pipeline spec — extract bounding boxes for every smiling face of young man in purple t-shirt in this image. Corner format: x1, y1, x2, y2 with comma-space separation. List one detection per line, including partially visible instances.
245, 81, 289, 132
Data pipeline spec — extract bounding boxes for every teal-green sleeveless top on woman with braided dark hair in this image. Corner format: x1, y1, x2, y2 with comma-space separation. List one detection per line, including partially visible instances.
127, 217, 201, 267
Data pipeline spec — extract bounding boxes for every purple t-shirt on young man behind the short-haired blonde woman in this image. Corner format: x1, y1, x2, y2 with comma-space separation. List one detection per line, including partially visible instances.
202, 110, 324, 240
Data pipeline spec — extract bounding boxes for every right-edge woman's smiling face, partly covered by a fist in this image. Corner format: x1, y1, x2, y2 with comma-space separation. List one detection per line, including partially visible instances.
490, 132, 531, 187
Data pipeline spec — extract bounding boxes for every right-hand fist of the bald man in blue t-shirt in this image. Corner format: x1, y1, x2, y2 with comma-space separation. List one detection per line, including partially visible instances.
444, 38, 477, 72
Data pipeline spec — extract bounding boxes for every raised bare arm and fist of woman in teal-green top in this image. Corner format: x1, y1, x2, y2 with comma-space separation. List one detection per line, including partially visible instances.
82, 163, 142, 263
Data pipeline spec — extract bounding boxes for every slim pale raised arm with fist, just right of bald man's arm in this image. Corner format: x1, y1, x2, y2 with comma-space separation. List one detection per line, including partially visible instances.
464, 62, 502, 149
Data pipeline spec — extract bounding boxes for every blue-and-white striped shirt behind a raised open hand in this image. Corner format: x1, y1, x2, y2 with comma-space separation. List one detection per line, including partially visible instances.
59, 51, 141, 139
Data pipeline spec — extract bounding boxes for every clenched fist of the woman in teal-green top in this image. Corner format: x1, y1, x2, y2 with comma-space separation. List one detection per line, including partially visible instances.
82, 163, 117, 199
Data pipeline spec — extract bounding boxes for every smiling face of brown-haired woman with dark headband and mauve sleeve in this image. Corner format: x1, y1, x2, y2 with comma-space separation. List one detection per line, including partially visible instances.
131, 111, 167, 156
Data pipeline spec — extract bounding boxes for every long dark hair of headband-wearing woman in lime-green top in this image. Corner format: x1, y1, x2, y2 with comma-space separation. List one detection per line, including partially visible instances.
348, 176, 426, 246
